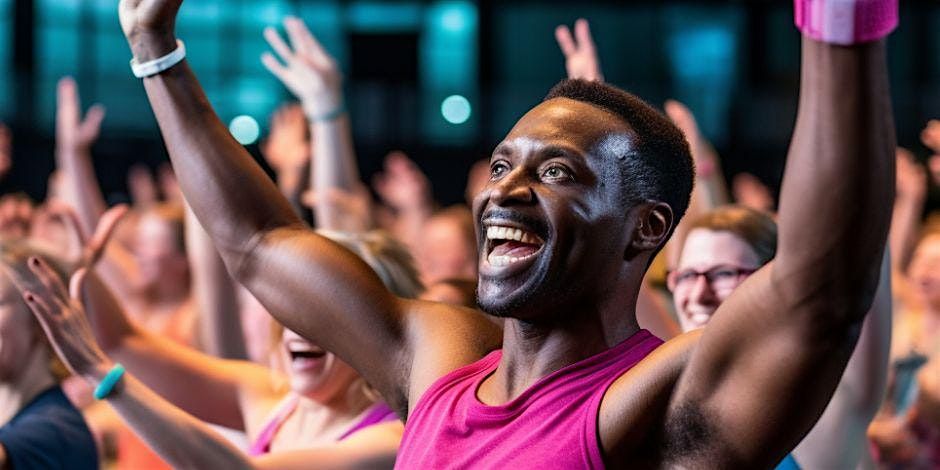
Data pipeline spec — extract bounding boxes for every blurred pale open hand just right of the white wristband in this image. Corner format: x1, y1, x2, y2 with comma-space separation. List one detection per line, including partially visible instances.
261, 16, 344, 120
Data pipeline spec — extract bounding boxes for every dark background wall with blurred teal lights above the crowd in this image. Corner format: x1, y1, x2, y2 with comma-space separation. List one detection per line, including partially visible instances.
0, 0, 940, 206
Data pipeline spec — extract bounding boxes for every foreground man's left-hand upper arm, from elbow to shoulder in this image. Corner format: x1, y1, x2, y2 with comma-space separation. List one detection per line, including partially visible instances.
229, 227, 410, 402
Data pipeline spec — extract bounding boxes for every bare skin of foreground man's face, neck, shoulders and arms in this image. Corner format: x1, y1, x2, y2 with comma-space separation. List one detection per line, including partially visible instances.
121, 0, 894, 467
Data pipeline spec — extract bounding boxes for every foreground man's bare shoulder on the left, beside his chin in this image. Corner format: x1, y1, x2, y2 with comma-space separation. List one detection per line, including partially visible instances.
405, 301, 503, 409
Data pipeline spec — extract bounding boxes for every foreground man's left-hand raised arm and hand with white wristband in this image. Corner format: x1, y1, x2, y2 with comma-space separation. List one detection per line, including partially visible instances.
120, 0, 409, 405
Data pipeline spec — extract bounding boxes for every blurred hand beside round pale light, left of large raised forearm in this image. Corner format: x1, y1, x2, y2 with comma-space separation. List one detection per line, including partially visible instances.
261, 103, 310, 175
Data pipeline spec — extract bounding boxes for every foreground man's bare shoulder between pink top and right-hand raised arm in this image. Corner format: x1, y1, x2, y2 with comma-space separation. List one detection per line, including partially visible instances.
598, 330, 701, 467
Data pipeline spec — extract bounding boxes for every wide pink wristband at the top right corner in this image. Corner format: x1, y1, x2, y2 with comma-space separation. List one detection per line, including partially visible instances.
793, 0, 898, 45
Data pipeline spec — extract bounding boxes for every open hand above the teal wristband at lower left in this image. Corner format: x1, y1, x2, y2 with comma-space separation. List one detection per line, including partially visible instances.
14, 257, 111, 379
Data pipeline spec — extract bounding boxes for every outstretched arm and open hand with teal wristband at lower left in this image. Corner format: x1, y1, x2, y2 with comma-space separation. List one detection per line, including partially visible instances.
14, 264, 402, 469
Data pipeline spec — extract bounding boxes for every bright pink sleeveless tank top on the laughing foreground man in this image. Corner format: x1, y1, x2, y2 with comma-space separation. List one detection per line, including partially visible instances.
395, 330, 662, 470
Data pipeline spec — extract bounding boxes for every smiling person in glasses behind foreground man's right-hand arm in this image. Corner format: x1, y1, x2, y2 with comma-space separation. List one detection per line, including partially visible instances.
667, 206, 891, 469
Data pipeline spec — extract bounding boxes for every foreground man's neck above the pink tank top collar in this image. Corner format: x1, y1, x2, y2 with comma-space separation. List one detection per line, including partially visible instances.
478, 305, 639, 405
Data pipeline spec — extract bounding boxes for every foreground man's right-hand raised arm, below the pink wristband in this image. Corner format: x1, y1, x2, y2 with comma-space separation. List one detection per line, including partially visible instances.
659, 24, 897, 468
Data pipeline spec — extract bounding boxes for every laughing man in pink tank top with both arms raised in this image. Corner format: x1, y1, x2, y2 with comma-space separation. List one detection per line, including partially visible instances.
121, 0, 897, 468
